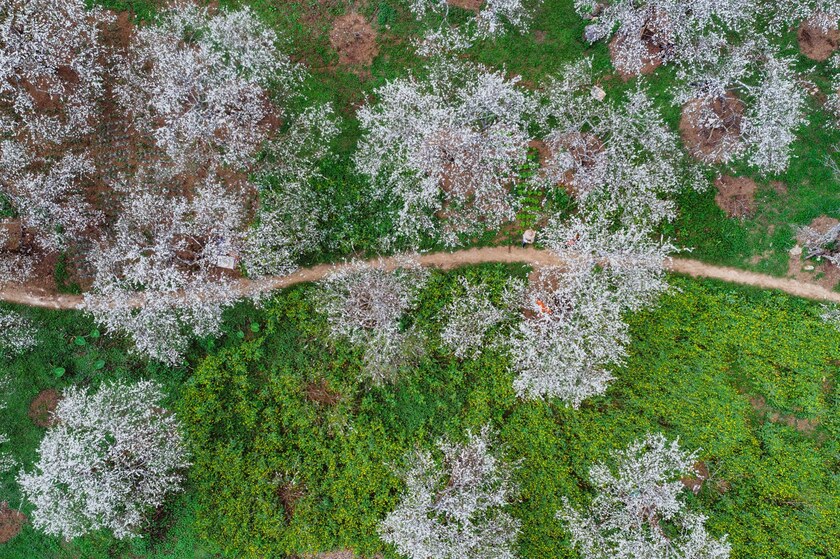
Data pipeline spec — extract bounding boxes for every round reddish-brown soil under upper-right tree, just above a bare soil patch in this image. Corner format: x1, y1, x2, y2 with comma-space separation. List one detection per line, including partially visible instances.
679, 93, 744, 163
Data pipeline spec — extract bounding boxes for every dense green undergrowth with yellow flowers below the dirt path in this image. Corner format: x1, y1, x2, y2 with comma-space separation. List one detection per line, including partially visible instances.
0, 265, 840, 559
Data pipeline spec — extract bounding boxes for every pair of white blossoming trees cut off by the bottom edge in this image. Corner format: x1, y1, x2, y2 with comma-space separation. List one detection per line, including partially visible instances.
379, 427, 730, 559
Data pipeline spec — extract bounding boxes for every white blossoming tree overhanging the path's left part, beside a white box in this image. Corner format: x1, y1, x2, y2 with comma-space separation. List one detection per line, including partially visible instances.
85, 176, 245, 363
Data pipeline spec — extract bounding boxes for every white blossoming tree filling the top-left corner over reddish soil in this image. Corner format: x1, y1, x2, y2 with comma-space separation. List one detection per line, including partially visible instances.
0, 0, 112, 144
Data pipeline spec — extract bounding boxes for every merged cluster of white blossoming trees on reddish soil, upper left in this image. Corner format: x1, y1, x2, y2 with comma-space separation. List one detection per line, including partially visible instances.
0, 0, 337, 363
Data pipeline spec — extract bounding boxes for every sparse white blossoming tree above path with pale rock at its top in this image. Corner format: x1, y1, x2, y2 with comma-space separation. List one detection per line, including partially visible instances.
538, 59, 706, 223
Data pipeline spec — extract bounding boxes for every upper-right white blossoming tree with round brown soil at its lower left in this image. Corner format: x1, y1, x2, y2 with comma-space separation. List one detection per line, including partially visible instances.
674, 40, 807, 174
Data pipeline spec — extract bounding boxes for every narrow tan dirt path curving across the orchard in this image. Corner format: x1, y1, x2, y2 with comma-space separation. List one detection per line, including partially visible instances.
0, 247, 840, 309
